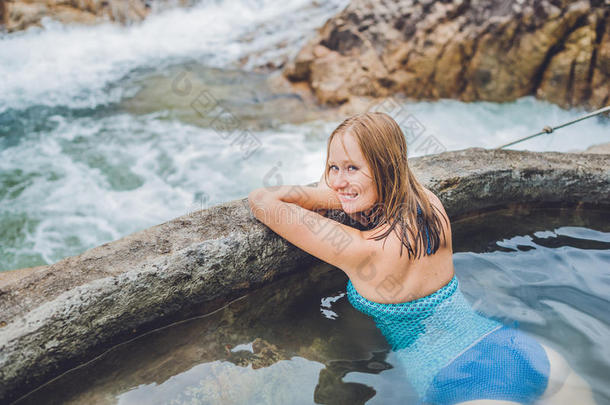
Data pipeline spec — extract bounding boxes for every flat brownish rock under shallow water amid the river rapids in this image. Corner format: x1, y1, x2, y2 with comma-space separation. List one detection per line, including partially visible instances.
121, 61, 340, 131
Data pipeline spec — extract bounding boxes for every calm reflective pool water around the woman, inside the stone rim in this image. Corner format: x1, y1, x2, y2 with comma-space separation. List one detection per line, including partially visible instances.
14, 207, 610, 404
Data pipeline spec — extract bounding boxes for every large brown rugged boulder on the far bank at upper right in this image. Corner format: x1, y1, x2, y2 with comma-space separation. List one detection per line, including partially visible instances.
284, 0, 610, 108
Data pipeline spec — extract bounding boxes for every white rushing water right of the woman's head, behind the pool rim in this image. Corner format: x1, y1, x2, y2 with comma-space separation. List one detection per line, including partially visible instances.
366, 97, 610, 157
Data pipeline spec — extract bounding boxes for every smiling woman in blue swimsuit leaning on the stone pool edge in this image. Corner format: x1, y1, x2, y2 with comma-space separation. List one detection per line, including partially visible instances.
248, 113, 594, 404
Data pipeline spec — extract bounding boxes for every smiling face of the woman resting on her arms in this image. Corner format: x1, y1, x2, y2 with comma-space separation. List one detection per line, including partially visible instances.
328, 131, 377, 214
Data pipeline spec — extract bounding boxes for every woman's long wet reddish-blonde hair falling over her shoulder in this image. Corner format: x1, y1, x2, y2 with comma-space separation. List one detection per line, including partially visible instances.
324, 112, 447, 258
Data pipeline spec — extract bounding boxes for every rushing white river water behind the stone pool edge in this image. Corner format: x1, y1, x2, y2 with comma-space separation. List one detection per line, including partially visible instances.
0, 0, 610, 271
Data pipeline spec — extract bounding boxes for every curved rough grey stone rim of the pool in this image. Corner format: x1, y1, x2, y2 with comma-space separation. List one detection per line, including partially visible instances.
0, 148, 610, 402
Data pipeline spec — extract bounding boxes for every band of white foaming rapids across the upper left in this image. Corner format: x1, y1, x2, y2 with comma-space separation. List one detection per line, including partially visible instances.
0, 0, 346, 112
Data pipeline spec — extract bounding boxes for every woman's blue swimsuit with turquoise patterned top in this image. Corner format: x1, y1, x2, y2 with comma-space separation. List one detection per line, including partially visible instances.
347, 207, 550, 404
